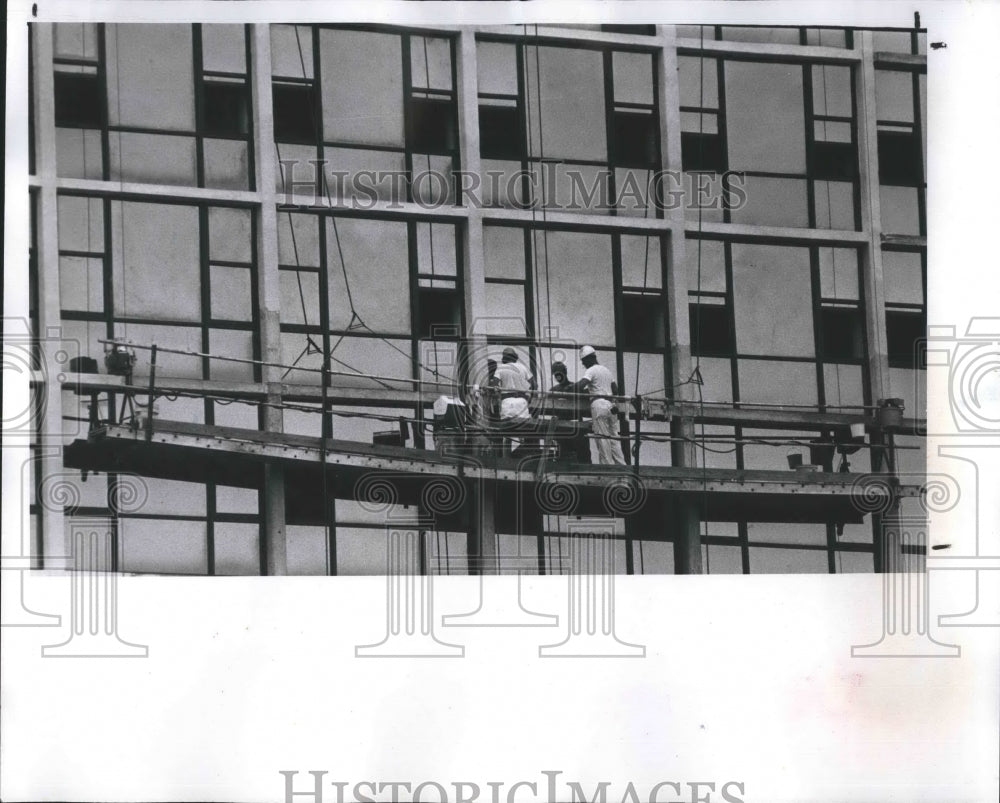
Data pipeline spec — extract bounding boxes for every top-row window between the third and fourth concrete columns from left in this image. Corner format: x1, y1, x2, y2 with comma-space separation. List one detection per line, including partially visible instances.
477, 40, 660, 215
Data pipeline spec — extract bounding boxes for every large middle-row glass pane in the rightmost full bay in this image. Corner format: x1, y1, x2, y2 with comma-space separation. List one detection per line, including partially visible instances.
732, 243, 815, 358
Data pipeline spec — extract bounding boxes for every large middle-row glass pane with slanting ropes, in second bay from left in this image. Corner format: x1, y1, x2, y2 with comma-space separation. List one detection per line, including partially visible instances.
326, 218, 410, 334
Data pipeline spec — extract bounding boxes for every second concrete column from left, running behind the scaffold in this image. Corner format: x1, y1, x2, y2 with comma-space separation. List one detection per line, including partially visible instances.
251, 23, 288, 575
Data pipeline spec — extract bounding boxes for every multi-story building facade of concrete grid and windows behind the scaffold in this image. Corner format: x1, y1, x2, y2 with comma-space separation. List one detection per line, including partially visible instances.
21, 23, 927, 575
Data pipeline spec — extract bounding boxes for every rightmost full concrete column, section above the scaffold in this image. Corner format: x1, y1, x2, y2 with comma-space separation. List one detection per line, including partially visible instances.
854, 31, 889, 408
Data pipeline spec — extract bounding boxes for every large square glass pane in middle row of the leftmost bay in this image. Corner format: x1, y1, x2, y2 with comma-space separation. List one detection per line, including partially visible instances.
111, 201, 201, 321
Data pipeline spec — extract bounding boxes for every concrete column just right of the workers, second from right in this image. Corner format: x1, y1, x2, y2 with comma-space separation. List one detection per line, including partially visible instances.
656, 25, 704, 574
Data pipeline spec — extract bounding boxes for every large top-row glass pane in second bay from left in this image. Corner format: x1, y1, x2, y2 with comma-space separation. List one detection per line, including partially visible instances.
319, 30, 403, 147
